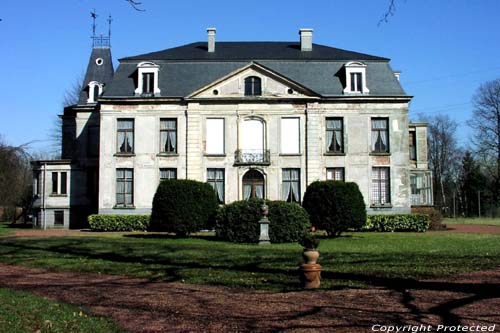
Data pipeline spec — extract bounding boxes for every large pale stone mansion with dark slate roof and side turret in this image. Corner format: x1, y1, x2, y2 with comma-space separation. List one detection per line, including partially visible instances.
33, 28, 432, 228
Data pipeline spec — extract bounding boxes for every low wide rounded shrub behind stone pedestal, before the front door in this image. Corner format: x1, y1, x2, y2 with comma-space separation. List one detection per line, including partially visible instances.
215, 199, 310, 243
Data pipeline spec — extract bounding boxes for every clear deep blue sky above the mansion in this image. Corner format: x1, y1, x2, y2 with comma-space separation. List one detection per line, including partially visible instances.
0, 0, 500, 151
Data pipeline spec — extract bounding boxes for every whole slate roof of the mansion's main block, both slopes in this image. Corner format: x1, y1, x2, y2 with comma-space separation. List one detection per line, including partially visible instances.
104, 42, 407, 98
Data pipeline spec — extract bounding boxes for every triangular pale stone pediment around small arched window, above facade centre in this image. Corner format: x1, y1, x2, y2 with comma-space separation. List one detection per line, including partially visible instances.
187, 62, 319, 99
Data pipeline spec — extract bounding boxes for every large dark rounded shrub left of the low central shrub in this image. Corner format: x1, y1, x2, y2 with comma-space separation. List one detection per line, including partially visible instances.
148, 179, 219, 236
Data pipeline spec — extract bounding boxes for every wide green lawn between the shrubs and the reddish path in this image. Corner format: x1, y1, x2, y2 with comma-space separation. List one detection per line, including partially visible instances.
0, 233, 500, 291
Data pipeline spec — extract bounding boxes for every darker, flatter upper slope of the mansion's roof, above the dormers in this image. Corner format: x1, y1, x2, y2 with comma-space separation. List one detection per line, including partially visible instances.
120, 42, 389, 61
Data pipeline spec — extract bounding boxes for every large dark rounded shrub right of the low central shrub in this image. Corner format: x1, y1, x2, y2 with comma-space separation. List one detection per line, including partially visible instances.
303, 180, 366, 237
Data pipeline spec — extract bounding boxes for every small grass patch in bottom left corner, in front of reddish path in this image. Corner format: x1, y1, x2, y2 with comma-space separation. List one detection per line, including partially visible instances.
0, 289, 123, 333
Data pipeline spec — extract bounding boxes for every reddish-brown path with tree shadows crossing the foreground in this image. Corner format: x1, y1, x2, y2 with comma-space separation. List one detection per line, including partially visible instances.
0, 264, 500, 333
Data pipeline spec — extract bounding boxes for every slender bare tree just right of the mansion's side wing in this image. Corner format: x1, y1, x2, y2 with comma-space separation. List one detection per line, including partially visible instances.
420, 115, 461, 211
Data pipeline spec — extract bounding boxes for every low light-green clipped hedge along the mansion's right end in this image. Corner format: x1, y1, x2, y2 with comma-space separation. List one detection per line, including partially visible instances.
363, 214, 430, 232
